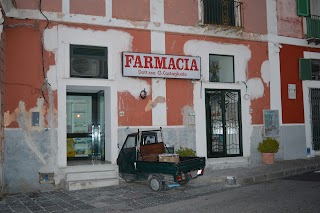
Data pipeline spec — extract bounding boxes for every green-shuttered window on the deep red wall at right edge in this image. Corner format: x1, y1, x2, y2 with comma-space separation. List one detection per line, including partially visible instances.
299, 58, 320, 81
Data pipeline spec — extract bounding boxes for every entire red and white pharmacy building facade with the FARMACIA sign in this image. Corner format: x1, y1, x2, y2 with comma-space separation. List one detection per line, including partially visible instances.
1, 0, 319, 192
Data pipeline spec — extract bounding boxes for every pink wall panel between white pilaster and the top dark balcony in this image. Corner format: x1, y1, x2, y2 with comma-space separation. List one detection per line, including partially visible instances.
164, 0, 199, 26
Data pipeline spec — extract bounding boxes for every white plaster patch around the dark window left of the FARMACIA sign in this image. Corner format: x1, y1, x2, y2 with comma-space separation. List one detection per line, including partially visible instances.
54, 25, 150, 99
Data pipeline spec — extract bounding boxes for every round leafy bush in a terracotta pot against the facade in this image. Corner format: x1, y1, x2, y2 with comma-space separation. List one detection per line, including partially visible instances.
258, 137, 279, 164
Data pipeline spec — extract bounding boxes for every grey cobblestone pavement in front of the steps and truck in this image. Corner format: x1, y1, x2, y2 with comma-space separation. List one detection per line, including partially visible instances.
0, 181, 227, 213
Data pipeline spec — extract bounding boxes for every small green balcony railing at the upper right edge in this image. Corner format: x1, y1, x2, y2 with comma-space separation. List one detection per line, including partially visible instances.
306, 15, 320, 44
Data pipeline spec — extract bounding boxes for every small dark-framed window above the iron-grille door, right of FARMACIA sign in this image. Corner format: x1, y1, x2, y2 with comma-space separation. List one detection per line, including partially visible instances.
209, 54, 234, 83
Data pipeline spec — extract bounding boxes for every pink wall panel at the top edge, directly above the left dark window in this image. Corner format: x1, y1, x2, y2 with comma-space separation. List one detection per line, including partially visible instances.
70, 0, 106, 16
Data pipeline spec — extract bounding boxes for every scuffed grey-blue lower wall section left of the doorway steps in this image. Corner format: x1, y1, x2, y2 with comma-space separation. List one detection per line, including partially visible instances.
4, 129, 56, 193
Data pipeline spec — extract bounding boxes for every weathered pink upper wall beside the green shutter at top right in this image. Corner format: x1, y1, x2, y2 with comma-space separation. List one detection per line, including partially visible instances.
277, 0, 303, 38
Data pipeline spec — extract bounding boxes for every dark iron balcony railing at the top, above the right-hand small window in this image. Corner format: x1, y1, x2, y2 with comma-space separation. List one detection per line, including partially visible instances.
203, 0, 243, 27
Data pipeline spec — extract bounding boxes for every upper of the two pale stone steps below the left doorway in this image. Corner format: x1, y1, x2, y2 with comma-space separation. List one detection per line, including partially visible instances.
66, 170, 118, 181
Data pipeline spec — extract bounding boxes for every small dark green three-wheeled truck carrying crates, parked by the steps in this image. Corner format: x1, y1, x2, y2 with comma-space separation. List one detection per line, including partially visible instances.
117, 128, 206, 191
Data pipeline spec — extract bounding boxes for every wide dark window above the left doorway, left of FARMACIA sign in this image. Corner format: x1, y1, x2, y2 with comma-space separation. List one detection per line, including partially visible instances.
70, 45, 108, 78
